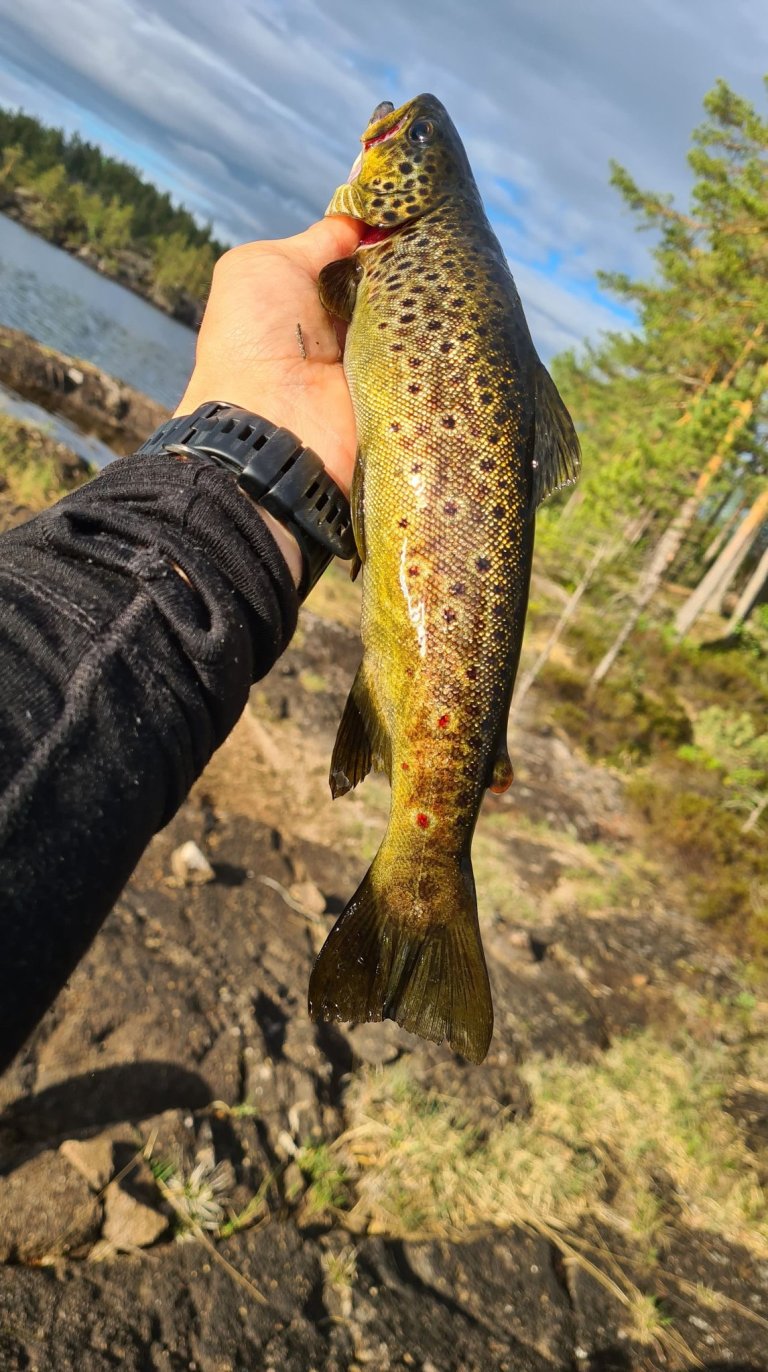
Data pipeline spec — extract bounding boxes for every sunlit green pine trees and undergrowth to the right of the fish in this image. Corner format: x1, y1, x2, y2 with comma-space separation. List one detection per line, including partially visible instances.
513, 82, 768, 951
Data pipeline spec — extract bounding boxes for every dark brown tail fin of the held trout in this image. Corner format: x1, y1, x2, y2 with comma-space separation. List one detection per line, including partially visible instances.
309, 849, 494, 1062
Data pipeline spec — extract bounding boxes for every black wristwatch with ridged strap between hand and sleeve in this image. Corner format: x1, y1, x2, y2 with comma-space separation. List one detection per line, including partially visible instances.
137, 401, 355, 600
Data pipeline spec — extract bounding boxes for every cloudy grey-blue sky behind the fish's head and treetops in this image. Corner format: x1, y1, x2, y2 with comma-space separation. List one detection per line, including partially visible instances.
0, 0, 768, 358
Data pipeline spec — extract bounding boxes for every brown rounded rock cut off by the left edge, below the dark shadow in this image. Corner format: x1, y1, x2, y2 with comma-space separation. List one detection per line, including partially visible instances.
0, 1151, 101, 1262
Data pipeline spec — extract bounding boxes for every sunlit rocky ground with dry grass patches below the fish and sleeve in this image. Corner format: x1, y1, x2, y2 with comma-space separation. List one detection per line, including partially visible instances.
0, 408, 768, 1372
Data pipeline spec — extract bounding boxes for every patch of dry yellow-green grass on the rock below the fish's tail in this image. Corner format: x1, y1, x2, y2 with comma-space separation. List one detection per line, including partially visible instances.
341, 1032, 768, 1257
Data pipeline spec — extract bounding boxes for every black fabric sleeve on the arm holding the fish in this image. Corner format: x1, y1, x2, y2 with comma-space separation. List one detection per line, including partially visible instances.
0, 456, 298, 1070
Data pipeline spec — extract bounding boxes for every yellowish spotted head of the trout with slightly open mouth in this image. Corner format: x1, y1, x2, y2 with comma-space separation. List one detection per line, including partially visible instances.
325, 95, 477, 247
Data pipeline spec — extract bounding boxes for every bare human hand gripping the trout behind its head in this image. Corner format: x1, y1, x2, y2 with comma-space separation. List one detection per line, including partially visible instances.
176, 217, 363, 502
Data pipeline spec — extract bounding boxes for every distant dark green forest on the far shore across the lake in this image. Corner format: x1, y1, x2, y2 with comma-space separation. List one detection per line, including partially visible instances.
0, 108, 224, 325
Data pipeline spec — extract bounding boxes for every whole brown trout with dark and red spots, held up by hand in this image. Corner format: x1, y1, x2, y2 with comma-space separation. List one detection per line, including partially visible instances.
309, 95, 579, 1062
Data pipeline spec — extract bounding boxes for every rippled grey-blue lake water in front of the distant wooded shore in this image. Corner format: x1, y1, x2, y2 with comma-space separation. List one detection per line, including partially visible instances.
0, 214, 195, 409
